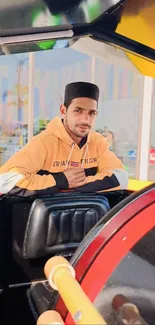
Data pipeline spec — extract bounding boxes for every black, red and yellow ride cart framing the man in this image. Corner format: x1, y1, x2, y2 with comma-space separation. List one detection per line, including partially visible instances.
0, 0, 155, 325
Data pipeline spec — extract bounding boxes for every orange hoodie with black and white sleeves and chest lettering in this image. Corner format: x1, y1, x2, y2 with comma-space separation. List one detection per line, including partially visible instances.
0, 117, 128, 196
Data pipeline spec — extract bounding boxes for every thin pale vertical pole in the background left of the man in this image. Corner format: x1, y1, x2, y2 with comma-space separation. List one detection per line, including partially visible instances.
28, 53, 34, 142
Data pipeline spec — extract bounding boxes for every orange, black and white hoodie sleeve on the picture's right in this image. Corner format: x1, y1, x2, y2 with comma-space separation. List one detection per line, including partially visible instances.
76, 136, 128, 192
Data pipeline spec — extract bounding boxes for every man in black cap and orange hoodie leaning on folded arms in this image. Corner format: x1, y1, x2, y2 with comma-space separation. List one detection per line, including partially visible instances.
0, 82, 128, 196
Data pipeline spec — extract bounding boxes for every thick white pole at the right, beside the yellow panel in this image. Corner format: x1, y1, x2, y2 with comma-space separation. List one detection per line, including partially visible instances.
139, 77, 153, 181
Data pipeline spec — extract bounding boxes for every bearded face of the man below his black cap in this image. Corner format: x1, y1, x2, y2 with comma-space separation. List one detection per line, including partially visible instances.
60, 98, 97, 138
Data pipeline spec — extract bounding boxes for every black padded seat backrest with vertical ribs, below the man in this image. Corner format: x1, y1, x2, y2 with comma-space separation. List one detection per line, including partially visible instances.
15, 194, 110, 259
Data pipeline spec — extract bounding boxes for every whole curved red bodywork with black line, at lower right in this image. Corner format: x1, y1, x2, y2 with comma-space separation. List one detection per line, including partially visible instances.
56, 187, 155, 324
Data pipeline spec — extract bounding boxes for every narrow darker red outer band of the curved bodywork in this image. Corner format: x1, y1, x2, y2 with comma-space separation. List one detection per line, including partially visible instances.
55, 188, 155, 317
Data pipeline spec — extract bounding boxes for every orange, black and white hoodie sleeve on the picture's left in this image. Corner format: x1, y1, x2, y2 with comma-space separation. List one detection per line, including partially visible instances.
0, 136, 68, 196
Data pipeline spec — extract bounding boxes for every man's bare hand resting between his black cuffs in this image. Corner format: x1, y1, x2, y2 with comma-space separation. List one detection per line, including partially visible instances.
63, 168, 86, 189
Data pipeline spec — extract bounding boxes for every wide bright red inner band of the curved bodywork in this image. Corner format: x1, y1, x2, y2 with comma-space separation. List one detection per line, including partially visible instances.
66, 203, 155, 324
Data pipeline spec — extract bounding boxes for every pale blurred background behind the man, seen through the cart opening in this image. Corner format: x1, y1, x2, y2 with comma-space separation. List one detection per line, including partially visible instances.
0, 48, 155, 180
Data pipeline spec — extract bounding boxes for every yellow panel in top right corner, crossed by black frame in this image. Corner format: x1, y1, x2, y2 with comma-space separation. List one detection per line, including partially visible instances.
116, 0, 155, 78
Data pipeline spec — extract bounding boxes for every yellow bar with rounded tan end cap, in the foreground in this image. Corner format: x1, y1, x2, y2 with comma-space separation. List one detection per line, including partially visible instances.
45, 257, 106, 325
